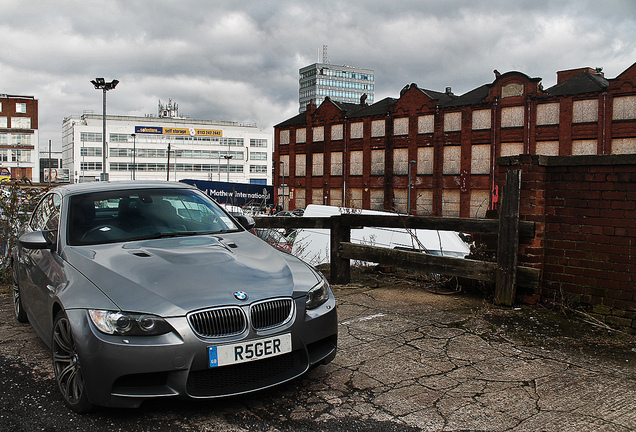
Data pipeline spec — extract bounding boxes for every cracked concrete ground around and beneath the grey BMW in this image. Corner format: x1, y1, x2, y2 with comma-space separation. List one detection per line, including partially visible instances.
0, 281, 636, 432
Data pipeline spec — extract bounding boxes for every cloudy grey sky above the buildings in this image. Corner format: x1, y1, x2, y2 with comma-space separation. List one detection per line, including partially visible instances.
0, 0, 636, 152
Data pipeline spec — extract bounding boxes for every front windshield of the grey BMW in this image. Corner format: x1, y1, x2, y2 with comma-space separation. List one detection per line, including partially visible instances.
67, 189, 241, 246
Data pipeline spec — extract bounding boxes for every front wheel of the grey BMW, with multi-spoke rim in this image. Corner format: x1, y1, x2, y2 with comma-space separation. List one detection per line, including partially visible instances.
51, 311, 95, 413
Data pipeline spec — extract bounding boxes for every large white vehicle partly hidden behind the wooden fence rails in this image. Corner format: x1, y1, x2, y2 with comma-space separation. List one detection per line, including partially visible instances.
292, 204, 470, 265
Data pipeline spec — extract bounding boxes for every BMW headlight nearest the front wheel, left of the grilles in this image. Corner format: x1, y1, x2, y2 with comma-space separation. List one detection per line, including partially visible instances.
88, 309, 172, 336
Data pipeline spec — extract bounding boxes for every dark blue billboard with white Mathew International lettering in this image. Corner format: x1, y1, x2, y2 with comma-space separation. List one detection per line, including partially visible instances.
179, 179, 274, 207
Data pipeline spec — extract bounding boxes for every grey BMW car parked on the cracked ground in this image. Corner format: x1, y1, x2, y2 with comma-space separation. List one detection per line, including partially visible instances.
12, 182, 337, 412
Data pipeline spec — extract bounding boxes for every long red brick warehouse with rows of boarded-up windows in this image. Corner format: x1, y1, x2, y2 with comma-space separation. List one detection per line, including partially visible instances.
274, 64, 636, 217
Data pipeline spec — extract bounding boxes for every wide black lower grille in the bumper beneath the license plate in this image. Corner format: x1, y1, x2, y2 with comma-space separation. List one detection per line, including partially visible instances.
187, 350, 309, 397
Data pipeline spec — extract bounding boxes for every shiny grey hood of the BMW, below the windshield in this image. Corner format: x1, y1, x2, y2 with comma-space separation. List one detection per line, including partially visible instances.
63, 232, 319, 316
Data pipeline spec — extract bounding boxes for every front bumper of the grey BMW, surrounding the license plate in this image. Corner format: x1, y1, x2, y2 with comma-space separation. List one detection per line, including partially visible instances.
66, 293, 338, 407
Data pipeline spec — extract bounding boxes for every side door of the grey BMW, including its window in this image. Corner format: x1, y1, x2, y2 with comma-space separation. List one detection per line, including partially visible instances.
19, 193, 63, 340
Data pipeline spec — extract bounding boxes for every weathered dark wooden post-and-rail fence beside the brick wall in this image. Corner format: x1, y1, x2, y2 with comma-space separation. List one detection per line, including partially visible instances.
255, 170, 539, 305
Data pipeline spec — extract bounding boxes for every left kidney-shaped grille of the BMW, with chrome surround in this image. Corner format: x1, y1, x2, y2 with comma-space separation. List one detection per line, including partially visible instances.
188, 307, 247, 337
